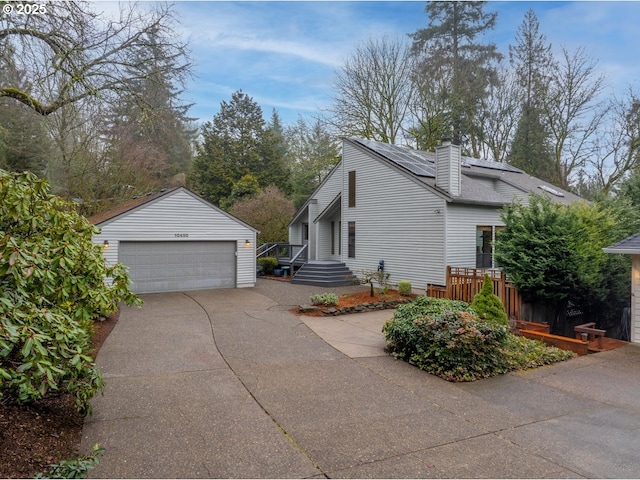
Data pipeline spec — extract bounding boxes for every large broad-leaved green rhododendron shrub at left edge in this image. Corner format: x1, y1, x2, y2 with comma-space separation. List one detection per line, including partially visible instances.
0, 170, 141, 413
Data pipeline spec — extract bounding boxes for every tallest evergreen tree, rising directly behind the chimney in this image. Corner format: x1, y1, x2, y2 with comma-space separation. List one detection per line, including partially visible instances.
411, 1, 502, 156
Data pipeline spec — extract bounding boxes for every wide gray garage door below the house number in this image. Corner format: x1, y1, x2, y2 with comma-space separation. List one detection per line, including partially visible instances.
118, 241, 236, 293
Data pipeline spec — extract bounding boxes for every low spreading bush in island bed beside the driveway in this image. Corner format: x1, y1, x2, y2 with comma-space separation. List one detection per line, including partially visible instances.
383, 297, 573, 381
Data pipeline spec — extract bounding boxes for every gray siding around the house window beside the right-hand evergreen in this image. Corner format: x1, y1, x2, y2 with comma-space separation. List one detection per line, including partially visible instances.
446, 203, 504, 267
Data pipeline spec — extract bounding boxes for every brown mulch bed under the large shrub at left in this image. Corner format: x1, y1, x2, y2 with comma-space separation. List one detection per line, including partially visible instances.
0, 314, 118, 478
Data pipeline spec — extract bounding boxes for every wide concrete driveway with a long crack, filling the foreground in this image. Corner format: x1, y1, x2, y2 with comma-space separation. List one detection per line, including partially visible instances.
82, 280, 640, 478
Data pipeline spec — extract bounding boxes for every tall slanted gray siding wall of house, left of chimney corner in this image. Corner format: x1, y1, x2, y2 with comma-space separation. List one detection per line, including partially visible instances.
342, 142, 445, 289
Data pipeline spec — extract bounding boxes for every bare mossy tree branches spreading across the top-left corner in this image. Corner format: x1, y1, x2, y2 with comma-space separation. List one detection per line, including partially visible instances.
0, 1, 189, 115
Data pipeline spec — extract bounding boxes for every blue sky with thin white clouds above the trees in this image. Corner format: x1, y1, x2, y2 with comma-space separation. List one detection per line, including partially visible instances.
107, 1, 640, 125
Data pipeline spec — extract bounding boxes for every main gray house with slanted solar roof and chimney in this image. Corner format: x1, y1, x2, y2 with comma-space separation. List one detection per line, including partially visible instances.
289, 138, 580, 290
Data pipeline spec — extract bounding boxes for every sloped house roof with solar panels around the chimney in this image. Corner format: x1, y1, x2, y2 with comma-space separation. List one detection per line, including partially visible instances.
347, 137, 581, 205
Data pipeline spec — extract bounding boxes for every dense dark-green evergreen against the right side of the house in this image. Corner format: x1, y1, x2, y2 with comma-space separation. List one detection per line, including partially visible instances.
495, 195, 639, 334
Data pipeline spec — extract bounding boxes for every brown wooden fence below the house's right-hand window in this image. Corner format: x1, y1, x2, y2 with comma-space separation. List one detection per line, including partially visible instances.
427, 266, 521, 319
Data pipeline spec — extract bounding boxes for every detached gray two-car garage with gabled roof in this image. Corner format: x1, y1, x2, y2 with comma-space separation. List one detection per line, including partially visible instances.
89, 187, 257, 293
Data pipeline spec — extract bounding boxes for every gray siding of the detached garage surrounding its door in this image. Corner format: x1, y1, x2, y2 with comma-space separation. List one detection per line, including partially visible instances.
94, 190, 256, 287
